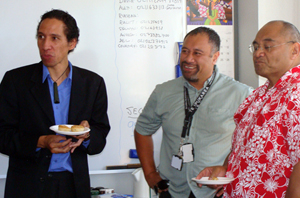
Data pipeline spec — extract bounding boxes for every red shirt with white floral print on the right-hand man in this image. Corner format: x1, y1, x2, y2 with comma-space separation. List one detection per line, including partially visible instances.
224, 65, 300, 198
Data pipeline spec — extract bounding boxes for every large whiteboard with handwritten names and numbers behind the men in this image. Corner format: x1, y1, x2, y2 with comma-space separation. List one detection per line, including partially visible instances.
0, 0, 185, 175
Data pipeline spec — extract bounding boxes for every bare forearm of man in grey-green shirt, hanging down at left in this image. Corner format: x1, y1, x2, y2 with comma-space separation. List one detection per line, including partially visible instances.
134, 130, 162, 188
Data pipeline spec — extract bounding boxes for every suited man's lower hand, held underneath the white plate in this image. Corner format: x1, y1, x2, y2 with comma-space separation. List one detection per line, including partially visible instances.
37, 135, 72, 153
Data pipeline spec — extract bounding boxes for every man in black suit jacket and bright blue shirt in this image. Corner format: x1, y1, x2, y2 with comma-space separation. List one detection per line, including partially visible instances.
0, 10, 110, 198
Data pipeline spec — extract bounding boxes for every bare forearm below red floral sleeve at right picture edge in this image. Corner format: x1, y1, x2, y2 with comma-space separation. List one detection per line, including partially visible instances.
285, 162, 300, 198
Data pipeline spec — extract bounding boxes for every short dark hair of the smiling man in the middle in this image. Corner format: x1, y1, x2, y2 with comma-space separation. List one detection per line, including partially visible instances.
184, 27, 221, 53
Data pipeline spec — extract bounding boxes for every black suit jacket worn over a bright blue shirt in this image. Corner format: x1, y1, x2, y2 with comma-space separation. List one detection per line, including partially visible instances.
0, 62, 110, 198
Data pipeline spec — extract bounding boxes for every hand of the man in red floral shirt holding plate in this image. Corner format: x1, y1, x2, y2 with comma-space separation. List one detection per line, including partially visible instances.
196, 166, 226, 197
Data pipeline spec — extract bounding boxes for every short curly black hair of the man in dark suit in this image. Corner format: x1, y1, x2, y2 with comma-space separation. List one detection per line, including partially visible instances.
37, 9, 79, 52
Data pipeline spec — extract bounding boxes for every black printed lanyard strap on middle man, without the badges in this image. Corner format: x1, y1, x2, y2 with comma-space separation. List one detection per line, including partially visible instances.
180, 70, 216, 145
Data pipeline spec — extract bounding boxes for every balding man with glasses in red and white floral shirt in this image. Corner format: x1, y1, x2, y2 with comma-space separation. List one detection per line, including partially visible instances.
197, 21, 300, 198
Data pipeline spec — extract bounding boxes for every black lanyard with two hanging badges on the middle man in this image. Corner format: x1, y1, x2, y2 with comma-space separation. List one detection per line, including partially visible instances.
171, 71, 216, 171
